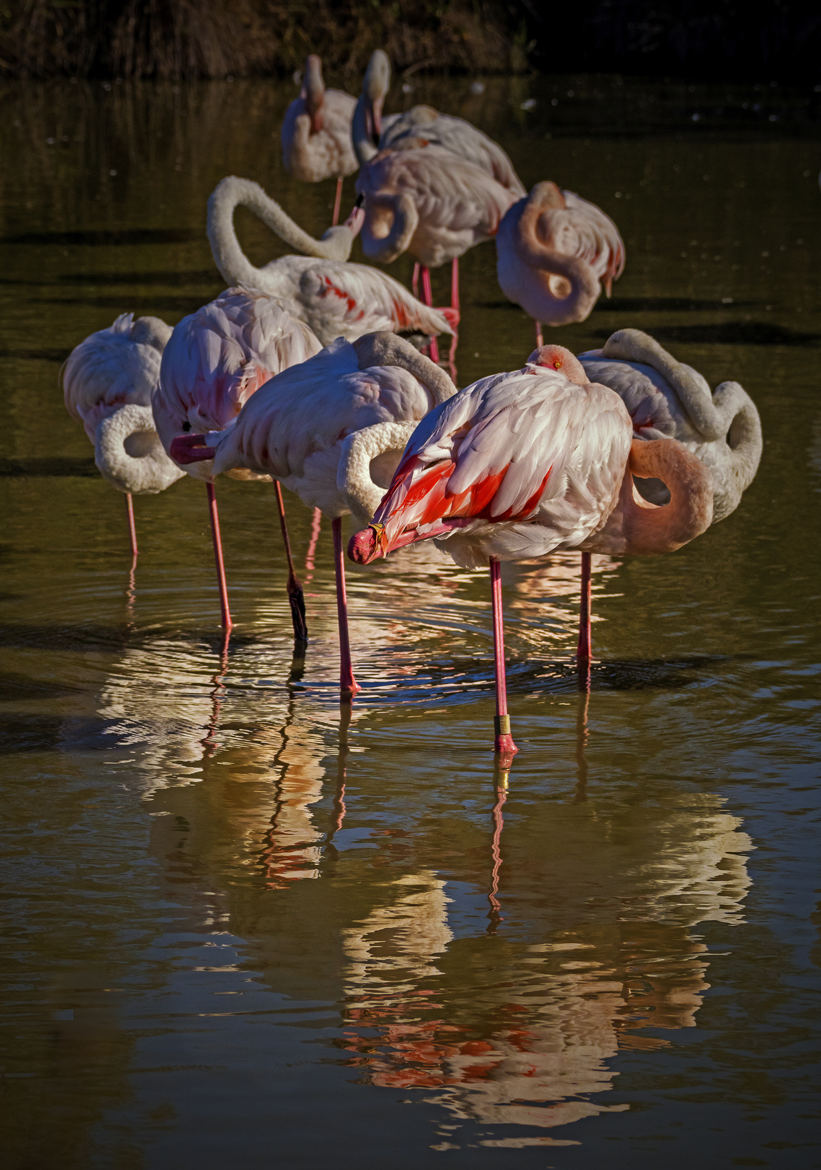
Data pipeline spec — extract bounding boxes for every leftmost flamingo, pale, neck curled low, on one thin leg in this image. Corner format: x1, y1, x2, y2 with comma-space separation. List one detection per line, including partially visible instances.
62, 312, 184, 559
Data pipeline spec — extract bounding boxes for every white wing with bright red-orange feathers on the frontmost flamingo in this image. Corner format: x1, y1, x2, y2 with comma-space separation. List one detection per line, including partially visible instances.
374, 369, 632, 551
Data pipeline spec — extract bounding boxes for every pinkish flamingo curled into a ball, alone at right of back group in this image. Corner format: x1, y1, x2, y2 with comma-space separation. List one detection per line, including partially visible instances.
496, 181, 625, 345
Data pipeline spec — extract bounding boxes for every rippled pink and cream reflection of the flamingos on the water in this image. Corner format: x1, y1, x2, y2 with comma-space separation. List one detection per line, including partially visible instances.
105, 641, 752, 1149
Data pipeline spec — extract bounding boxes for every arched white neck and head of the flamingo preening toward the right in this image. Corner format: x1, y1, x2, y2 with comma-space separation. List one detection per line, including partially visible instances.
207, 176, 356, 294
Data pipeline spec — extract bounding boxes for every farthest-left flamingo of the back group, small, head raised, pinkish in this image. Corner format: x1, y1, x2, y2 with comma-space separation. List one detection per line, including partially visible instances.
282, 53, 359, 223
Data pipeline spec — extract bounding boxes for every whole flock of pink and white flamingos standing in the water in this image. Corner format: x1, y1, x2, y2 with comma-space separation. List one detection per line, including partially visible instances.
63, 49, 761, 763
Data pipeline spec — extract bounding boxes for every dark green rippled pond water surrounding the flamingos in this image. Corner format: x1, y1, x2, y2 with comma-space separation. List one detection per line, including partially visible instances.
0, 77, 821, 1170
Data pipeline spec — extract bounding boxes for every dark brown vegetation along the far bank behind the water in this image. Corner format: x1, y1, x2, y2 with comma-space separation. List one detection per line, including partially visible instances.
0, 0, 821, 84
